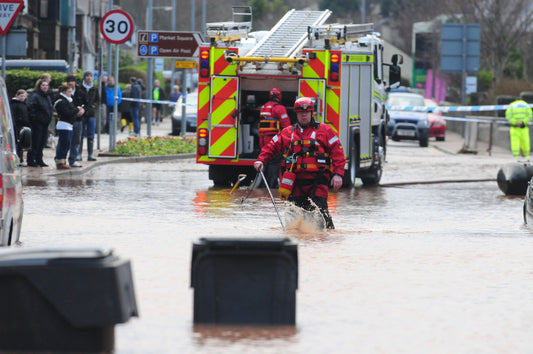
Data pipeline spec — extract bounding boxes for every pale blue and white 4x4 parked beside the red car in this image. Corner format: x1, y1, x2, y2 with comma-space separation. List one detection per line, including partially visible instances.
387, 92, 430, 147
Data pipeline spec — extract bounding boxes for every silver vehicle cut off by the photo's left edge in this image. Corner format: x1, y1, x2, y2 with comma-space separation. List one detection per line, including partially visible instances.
0, 77, 24, 246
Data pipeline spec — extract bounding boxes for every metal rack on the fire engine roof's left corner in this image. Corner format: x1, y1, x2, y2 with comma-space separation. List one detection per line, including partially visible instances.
205, 6, 252, 42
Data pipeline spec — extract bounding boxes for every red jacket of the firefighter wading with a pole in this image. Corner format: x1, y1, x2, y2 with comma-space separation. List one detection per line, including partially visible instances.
257, 123, 346, 198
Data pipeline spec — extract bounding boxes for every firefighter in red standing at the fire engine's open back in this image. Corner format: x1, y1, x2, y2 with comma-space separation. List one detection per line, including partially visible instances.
259, 87, 291, 188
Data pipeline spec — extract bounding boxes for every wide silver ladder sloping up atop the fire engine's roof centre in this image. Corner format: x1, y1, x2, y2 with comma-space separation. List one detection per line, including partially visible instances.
247, 9, 331, 58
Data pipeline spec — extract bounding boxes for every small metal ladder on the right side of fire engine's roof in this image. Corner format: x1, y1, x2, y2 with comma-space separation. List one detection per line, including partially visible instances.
307, 23, 374, 42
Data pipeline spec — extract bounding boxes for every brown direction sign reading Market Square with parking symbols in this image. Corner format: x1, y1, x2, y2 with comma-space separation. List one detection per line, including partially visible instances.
137, 31, 203, 60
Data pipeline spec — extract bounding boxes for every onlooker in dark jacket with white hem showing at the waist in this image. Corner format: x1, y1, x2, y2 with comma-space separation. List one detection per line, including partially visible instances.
54, 85, 85, 170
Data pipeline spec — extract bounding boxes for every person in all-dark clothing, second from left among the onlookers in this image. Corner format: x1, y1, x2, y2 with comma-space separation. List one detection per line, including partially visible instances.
28, 79, 53, 167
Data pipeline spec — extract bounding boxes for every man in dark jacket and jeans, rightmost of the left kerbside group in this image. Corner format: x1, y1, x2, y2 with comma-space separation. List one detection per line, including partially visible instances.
79, 71, 100, 161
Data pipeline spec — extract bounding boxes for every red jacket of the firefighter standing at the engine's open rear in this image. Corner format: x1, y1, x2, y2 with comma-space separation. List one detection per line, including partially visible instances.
259, 101, 291, 147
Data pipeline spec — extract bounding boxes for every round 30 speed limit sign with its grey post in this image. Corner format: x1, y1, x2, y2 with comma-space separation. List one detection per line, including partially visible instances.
98, 10, 134, 152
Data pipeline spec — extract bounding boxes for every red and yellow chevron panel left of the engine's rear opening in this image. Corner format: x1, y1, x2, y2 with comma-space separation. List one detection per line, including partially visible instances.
209, 76, 239, 158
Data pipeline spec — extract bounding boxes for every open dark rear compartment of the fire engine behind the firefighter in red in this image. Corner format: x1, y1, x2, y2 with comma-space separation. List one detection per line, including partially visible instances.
238, 76, 298, 160
